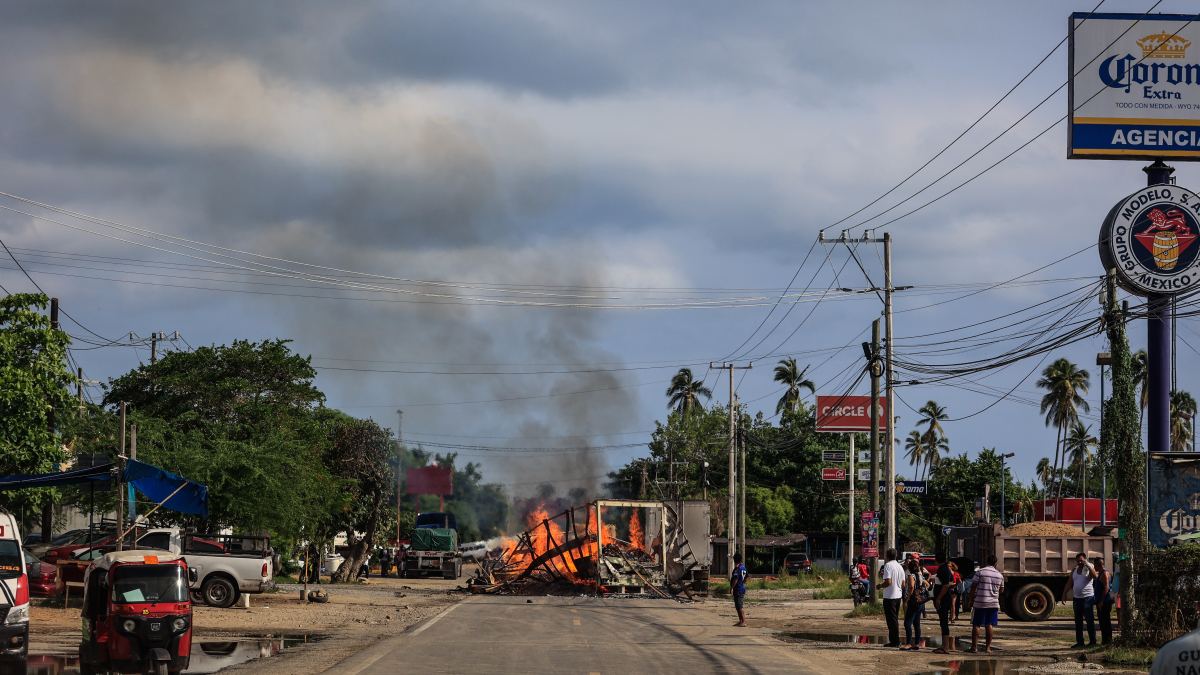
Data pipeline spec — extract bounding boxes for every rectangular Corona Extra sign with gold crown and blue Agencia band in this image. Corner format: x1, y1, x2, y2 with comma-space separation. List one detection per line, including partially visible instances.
1067, 12, 1200, 160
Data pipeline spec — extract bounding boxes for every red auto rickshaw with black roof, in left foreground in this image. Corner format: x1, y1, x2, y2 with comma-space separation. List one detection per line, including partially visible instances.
79, 550, 193, 675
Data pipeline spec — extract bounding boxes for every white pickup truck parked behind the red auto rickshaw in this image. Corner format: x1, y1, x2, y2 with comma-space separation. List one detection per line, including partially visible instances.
130, 527, 275, 607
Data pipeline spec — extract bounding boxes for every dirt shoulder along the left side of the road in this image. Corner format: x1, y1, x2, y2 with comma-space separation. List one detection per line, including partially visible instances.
30, 569, 466, 675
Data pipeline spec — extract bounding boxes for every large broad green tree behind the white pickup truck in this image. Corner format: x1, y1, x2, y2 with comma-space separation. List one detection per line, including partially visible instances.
94, 340, 333, 538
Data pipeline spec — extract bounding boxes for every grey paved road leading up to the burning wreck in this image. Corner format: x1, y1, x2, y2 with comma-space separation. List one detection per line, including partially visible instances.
348, 596, 812, 675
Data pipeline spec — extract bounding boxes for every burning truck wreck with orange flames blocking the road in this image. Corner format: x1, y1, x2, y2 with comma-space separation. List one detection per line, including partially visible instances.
468, 500, 710, 598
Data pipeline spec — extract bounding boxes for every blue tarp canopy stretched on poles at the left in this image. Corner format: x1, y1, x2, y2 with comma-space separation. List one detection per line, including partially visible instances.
0, 459, 209, 516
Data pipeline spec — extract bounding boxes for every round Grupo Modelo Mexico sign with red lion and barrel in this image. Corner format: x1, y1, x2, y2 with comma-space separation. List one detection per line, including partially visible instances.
1099, 185, 1200, 295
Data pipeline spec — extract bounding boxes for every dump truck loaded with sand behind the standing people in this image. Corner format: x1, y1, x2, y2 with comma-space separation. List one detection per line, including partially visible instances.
946, 522, 1116, 621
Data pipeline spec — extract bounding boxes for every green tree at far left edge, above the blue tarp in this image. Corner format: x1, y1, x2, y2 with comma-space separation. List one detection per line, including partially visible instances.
0, 294, 74, 526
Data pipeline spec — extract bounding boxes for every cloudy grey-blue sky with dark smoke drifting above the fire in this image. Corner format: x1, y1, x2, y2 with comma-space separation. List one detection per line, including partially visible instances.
0, 0, 1200, 494
